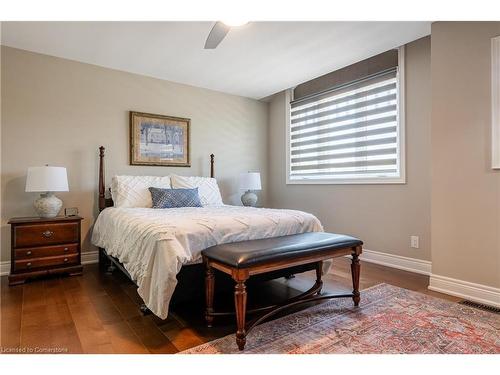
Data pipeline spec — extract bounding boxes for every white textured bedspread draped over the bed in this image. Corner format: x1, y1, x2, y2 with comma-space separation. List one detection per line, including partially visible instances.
92, 206, 323, 319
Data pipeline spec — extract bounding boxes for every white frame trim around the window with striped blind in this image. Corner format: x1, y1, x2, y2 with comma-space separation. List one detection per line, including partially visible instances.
285, 46, 406, 185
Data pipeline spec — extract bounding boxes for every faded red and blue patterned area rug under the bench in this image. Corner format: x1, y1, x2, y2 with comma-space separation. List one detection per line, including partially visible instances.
181, 284, 500, 354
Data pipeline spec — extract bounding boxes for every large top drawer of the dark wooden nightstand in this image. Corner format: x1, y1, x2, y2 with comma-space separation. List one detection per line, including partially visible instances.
13, 222, 80, 248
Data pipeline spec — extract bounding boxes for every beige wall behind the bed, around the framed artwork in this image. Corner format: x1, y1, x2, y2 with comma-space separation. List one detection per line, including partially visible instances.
1, 47, 267, 260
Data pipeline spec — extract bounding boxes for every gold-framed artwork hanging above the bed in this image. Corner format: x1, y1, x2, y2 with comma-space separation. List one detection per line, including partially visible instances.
130, 112, 191, 167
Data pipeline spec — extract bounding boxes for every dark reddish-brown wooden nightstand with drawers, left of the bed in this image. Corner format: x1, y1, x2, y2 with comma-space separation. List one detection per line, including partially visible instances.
9, 216, 82, 285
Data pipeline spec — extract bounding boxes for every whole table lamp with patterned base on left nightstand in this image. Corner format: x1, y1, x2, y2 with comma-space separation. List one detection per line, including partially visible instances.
26, 165, 69, 218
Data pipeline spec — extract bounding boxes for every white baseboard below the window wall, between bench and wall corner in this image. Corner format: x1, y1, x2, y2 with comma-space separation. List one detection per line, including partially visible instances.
360, 249, 432, 276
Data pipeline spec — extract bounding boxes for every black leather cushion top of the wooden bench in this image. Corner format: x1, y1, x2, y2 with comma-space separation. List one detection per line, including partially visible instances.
202, 232, 363, 268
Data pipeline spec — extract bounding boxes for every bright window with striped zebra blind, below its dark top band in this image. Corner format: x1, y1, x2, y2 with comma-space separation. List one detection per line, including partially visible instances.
287, 48, 405, 184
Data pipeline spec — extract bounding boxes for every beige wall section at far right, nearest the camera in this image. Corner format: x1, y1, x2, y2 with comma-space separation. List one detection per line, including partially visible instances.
431, 22, 500, 287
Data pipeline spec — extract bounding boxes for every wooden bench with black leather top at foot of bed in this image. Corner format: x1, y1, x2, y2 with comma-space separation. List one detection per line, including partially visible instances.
202, 232, 363, 350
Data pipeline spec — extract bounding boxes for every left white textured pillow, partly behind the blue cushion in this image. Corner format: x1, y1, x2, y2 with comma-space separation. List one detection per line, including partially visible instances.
111, 176, 170, 208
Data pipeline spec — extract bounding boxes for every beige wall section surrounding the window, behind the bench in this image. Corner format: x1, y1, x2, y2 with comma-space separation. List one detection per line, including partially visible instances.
269, 37, 431, 260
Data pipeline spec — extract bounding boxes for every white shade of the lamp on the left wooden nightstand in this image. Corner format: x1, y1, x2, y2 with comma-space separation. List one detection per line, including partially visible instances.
26, 166, 69, 192
